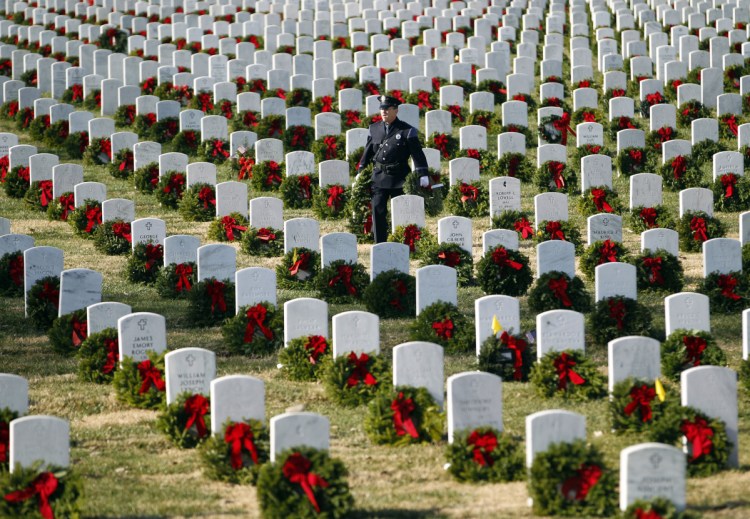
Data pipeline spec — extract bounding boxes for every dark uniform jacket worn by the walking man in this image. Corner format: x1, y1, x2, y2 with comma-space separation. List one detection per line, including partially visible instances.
357, 118, 427, 189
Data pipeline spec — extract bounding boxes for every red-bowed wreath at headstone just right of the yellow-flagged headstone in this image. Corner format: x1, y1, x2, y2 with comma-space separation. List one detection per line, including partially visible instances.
530, 350, 607, 402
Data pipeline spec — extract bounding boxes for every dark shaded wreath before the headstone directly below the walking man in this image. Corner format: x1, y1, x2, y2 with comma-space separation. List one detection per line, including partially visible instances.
362, 270, 416, 319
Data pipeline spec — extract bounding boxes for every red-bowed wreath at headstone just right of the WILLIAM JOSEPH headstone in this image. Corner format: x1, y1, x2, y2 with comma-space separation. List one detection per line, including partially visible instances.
198, 419, 270, 485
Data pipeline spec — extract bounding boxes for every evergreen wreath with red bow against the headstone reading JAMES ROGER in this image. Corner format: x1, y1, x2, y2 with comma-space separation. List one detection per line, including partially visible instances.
112, 351, 167, 409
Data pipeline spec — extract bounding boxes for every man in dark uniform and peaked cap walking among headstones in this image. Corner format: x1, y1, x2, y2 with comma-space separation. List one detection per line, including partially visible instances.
357, 96, 429, 243
